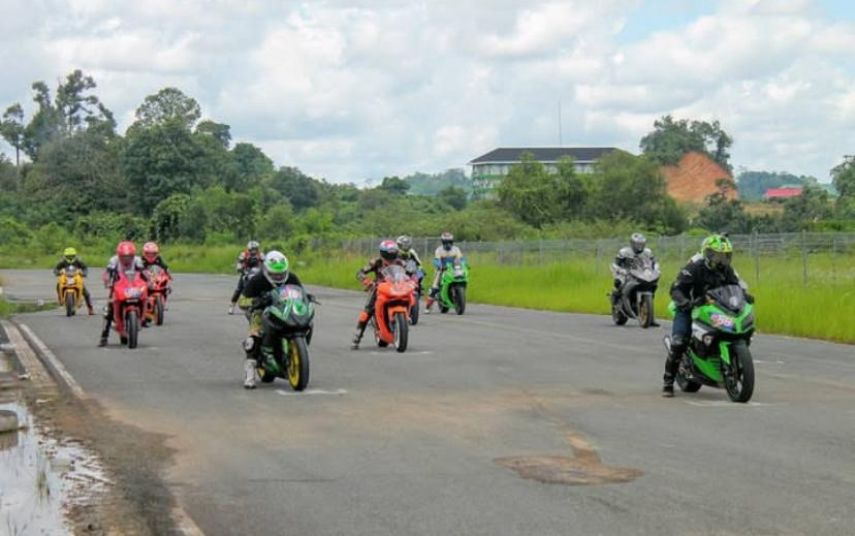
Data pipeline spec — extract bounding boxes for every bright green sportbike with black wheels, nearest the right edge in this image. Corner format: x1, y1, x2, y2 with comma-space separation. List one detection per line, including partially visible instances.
665, 285, 754, 403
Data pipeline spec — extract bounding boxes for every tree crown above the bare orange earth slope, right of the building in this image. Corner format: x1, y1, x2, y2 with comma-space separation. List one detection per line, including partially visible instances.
640, 115, 733, 171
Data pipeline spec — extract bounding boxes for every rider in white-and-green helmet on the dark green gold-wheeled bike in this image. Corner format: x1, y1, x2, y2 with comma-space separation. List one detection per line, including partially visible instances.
240, 250, 312, 389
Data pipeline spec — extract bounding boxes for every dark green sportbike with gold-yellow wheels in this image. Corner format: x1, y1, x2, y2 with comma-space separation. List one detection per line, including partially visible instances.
258, 285, 317, 391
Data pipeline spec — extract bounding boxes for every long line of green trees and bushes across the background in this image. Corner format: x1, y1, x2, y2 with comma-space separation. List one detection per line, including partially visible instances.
0, 70, 855, 258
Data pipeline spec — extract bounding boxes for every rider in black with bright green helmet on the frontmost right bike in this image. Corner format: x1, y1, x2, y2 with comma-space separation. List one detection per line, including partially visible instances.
662, 234, 754, 398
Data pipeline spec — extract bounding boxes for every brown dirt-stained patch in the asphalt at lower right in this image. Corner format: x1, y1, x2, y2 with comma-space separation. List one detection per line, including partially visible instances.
494, 433, 644, 486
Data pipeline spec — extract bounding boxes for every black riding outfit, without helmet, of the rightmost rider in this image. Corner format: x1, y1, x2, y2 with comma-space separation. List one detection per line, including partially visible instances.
664, 256, 753, 385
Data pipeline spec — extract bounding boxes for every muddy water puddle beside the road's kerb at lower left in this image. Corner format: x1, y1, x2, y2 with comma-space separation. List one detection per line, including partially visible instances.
0, 393, 109, 536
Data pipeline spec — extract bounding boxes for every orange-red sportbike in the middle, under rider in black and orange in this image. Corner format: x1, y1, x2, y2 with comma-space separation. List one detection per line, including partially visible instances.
371, 264, 416, 352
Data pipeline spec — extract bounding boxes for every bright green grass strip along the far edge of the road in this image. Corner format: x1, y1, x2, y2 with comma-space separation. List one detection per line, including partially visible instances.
0, 245, 855, 343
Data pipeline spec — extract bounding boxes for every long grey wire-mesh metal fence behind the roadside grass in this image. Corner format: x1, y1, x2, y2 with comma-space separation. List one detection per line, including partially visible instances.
340, 232, 855, 284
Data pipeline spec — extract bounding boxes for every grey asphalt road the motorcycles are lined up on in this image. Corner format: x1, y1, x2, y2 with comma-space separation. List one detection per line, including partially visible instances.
2, 271, 855, 536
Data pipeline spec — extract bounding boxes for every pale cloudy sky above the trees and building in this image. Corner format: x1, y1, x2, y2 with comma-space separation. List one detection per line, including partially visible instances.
0, 0, 855, 182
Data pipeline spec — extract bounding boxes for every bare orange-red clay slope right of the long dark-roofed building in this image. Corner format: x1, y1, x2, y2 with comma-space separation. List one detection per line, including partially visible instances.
662, 152, 739, 204
